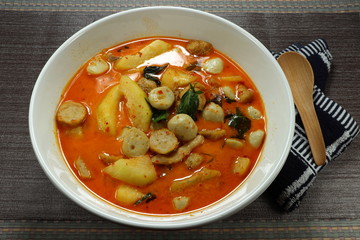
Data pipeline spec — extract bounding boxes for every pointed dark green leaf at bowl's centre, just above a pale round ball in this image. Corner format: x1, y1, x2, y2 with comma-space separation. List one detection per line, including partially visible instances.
177, 84, 202, 121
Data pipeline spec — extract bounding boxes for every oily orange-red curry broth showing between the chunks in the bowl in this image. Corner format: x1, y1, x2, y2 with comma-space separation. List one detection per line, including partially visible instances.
57, 37, 265, 214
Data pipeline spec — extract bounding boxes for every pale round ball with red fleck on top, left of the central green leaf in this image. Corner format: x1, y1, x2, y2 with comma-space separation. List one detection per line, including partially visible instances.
148, 86, 175, 110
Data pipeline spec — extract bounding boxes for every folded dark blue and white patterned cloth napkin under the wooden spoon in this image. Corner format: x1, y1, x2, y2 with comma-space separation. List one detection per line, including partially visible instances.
268, 39, 359, 211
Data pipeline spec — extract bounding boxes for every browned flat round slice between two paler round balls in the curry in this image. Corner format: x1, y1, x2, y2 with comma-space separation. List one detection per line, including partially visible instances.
150, 128, 179, 154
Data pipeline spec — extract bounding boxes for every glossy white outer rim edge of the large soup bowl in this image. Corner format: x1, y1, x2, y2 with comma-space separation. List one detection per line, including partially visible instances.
28, 6, 295, 229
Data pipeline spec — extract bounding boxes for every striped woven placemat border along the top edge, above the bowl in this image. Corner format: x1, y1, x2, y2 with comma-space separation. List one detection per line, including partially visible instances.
0, 0, 360, 13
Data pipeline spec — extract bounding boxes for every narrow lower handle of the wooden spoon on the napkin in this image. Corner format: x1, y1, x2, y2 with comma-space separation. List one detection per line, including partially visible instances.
296, 97, 326, 166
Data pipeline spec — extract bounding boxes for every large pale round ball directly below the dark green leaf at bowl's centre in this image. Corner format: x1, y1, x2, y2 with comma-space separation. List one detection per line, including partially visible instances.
167, 113, 198, 141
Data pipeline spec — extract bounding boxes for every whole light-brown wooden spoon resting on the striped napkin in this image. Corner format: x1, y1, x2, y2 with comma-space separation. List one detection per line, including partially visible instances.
278, 52, 326, 165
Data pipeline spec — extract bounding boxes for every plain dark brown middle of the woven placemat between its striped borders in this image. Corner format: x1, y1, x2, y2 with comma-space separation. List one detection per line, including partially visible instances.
0, 8, 360, 238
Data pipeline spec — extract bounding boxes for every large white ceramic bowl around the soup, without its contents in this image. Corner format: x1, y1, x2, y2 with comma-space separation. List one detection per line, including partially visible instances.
29, 7, 295, 229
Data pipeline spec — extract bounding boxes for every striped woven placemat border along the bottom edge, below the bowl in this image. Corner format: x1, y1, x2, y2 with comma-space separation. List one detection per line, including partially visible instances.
0, 219, 360, 240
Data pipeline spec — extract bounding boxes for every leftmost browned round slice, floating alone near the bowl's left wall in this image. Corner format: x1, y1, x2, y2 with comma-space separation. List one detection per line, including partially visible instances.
56, 101, 87, 127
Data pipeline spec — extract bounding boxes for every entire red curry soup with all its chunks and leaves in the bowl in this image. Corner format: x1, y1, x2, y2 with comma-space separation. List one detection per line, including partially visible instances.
56, 37, 266, 214
